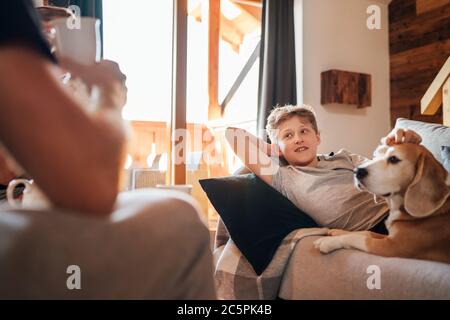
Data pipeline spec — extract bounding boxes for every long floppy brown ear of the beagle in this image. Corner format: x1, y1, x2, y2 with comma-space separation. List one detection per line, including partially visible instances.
404, 152, 450, 218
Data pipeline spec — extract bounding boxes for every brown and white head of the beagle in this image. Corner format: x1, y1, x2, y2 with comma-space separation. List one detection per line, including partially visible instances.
355, 143, 450, 217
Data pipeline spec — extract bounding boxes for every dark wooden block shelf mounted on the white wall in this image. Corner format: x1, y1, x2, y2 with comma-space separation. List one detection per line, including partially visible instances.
320, 70, 372, 108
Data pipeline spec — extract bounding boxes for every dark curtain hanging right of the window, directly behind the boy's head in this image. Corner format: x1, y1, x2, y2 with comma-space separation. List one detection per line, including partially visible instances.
258, 0, 297, 135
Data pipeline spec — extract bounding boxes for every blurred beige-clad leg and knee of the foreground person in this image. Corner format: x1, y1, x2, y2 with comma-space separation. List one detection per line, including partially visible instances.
0, 189, 215, 300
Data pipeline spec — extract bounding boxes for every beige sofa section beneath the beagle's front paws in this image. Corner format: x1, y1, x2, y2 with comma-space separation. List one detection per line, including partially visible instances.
279, 237, 450, 299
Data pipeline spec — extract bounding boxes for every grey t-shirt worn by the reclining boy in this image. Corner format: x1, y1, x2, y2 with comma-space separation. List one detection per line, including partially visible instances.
272, 150, 389, 231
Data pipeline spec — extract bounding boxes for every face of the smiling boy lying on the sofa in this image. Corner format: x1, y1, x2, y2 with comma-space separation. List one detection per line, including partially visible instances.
277, 116, 320, 167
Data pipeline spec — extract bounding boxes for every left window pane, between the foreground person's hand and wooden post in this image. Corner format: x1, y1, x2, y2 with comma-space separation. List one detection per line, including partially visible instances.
103, 0, 173, 183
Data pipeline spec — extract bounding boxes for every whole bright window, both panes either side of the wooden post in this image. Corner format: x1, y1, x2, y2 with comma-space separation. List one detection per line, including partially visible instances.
103, 0, 262, 223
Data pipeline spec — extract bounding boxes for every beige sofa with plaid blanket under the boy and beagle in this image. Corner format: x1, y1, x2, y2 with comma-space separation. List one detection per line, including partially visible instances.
214, 119, 450, 300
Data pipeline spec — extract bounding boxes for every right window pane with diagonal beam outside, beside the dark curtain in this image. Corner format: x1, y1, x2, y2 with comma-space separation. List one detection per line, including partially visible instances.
187, 0, 262, 225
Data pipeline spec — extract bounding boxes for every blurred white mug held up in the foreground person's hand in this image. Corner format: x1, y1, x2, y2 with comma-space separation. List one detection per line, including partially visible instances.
52, 17, 101, 65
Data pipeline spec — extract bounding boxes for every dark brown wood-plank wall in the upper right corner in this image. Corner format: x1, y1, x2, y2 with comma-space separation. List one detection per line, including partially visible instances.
389, 0, 450, 126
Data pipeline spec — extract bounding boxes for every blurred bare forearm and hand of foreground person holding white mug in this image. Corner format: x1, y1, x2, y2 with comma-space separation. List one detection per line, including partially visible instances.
0, 44, 126, 216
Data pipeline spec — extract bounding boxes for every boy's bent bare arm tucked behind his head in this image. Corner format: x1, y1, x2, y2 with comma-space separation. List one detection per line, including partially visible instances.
225, 128, 279, 185
